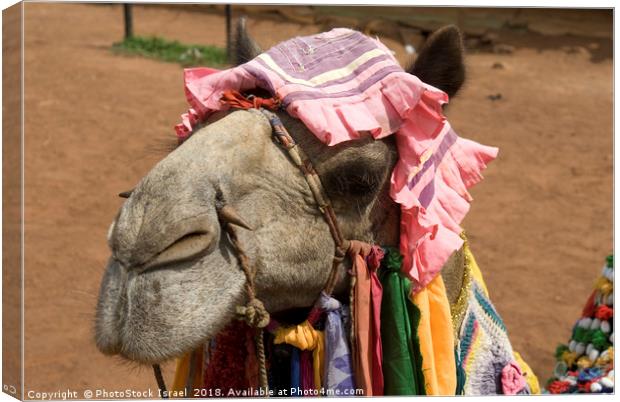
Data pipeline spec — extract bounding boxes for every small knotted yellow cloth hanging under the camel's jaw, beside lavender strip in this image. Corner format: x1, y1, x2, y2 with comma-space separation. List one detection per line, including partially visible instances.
273, 321, 325, 391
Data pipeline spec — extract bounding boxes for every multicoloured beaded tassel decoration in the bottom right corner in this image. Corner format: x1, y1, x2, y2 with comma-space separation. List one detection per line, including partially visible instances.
546, 255, 614, 394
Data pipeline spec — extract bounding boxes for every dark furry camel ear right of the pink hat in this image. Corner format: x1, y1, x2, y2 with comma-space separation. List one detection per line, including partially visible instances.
407, 25, 465, 97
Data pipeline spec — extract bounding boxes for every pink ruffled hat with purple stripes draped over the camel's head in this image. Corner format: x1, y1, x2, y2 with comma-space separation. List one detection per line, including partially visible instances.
176, 28, 498, 292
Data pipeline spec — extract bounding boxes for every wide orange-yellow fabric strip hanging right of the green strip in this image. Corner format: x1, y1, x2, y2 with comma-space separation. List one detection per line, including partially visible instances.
412, 275, 456, 395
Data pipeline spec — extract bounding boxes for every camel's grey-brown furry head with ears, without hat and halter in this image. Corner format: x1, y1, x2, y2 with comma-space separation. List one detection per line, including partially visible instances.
95, 25, 464, 363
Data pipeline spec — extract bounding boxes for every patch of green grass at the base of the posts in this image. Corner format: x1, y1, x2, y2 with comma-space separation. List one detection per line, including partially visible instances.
112, 36, 227, 67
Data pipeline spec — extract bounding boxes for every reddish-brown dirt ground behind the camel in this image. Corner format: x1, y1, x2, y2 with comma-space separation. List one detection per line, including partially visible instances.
18, 3, 613, 397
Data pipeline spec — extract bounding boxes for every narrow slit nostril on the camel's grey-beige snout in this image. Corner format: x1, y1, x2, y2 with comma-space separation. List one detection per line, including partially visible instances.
139, 231, 215, 272
